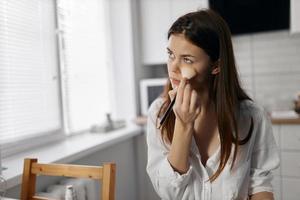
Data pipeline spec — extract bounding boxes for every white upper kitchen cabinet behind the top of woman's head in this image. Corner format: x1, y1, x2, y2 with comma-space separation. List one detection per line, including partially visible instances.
140, 0, 208, 65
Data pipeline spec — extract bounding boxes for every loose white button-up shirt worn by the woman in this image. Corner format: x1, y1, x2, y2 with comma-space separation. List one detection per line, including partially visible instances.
147, 98, 280, 200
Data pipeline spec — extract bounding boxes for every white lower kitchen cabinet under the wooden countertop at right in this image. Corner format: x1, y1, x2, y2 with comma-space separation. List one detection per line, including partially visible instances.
273, 124, 300, 200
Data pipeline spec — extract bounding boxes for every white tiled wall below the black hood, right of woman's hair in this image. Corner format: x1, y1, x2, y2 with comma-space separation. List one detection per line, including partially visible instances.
233, 31, 300, 109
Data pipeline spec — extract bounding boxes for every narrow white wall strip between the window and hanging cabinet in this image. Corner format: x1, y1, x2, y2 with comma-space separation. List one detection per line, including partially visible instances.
107, 0, 136, 119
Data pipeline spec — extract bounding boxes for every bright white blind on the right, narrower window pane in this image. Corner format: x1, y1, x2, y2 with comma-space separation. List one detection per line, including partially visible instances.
57, 0, 111, 133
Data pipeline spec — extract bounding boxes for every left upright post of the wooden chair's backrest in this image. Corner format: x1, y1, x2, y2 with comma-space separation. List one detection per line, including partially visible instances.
21, 158, 37, 200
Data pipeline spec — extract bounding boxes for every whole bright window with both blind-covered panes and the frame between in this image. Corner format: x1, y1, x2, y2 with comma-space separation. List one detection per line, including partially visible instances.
0, 0, 111, 156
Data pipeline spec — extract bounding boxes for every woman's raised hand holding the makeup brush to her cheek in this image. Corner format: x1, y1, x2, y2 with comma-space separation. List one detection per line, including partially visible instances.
169, 78, 200, 127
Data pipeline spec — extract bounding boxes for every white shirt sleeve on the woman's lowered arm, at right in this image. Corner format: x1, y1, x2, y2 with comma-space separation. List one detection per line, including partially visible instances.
249, 108, 280, 195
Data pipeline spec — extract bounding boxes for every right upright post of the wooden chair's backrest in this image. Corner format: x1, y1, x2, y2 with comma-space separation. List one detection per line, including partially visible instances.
102, 163, 116, 200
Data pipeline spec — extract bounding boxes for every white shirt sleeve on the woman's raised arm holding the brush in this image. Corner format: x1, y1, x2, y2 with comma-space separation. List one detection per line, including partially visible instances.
147, 98, 192, 200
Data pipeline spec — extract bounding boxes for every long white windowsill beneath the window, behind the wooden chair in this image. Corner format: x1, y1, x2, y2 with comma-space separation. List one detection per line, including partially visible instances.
0, 123, 142, 188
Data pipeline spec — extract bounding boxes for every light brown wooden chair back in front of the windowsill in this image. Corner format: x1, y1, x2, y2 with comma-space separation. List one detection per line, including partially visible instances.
21, 158, 116, 200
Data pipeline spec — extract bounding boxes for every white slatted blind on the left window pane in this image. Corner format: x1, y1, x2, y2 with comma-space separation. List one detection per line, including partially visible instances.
0, 0, 62, 144
